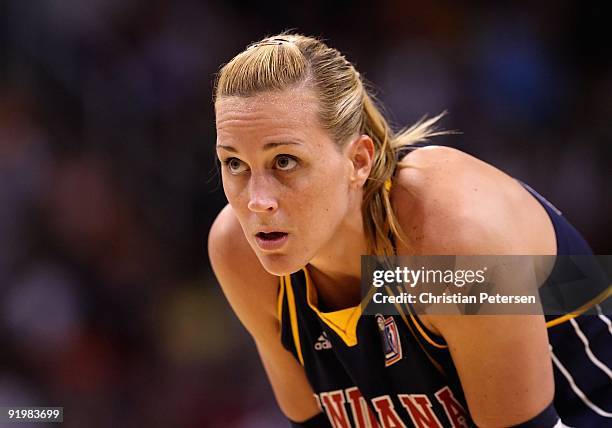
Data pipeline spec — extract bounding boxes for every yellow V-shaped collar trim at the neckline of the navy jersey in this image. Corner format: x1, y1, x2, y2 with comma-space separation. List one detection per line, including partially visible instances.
302, 268, 361, 347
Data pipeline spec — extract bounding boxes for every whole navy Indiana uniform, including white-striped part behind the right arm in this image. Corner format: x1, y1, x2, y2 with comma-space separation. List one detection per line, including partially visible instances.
277, 148, 612, 428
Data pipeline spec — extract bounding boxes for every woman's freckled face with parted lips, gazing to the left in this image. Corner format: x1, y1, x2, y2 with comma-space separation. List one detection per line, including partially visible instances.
215, 89, 359, 275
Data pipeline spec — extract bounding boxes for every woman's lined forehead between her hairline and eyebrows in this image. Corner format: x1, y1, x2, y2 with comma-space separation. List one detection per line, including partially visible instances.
215, 88, 323, 137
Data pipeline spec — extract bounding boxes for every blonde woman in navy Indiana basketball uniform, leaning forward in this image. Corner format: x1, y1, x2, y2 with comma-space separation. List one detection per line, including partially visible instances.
209, 34, 612, 427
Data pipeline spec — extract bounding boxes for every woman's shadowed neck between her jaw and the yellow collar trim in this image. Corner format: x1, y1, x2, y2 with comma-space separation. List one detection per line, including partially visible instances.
308, 205, 367, 311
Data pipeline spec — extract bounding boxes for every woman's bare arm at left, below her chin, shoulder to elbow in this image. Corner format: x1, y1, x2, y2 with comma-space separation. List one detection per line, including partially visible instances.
208, 205, 320, 421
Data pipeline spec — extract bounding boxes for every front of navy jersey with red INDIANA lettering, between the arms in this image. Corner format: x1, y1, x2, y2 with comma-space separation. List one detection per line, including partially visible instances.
279, 269, 473, 427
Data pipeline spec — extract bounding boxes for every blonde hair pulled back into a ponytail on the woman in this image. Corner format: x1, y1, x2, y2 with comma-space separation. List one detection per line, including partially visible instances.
215, 33, 445, 256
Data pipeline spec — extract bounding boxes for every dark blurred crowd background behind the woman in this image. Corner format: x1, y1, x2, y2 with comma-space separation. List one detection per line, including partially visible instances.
0, 0, 612, 428
